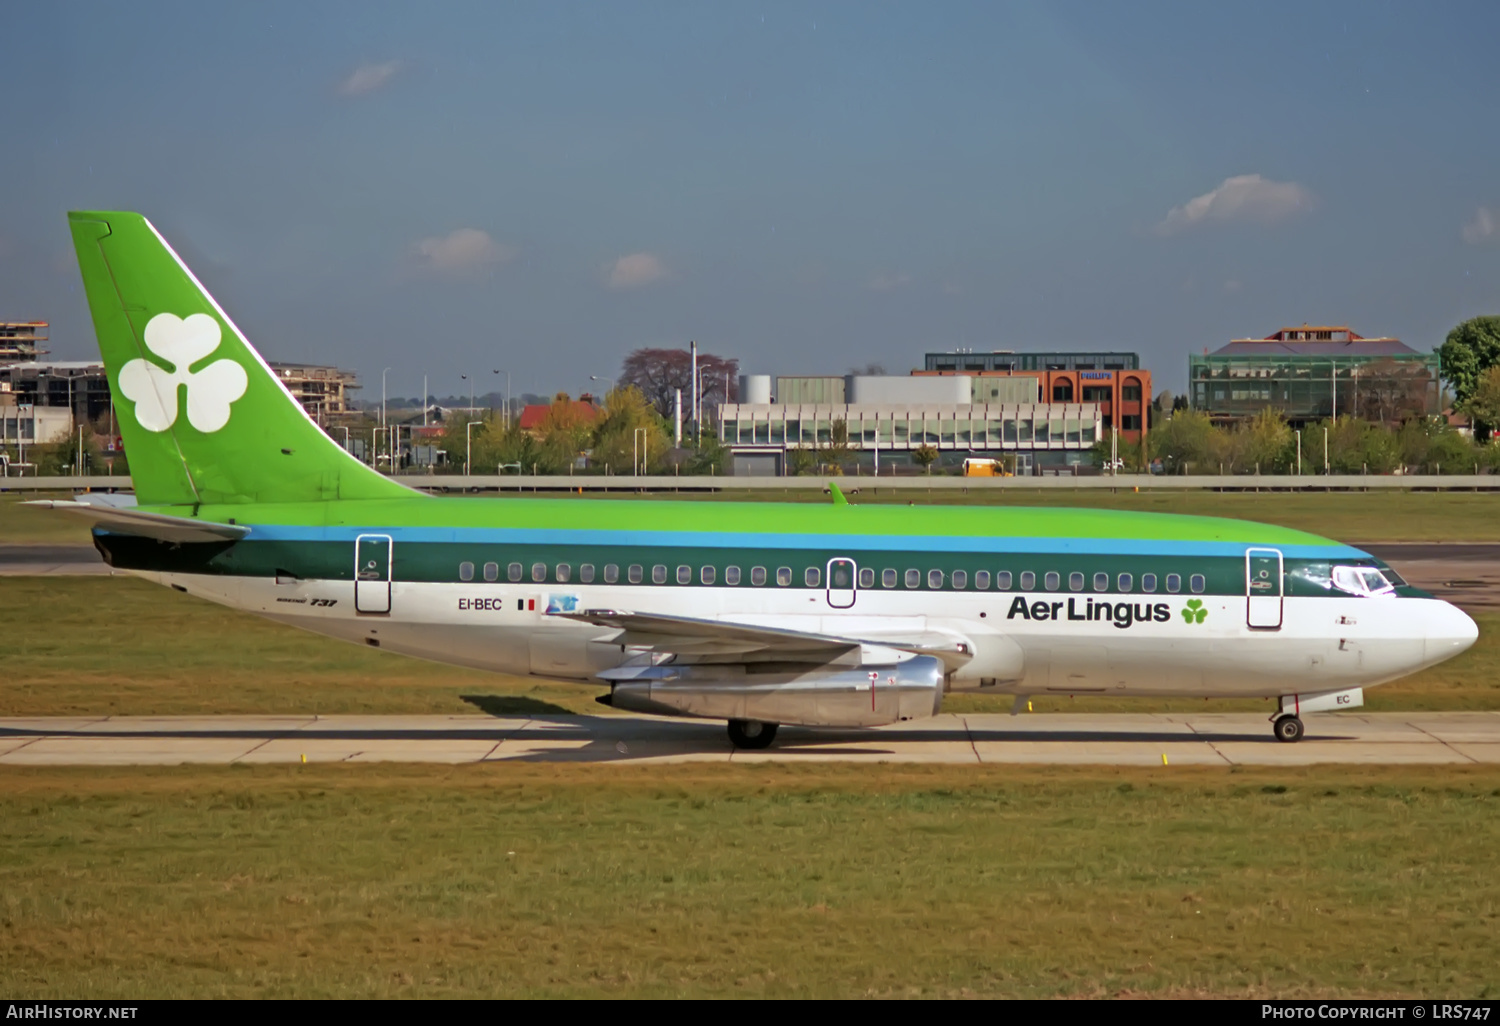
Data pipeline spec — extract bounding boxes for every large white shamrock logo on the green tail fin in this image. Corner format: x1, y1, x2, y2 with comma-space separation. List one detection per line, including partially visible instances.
120, 314, 249, 434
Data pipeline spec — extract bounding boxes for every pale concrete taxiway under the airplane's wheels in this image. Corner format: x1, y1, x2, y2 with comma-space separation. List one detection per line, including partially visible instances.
0, 713, 1500, 767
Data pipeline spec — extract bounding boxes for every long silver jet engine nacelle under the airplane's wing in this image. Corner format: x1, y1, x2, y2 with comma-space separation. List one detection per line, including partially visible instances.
609, 656, 944, 726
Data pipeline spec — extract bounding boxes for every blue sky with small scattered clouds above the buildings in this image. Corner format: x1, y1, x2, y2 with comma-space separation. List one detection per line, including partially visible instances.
0, 0, 1500, 398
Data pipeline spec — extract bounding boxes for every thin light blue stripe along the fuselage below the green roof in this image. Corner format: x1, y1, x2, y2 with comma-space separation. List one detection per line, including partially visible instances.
237, 524, 1370, 560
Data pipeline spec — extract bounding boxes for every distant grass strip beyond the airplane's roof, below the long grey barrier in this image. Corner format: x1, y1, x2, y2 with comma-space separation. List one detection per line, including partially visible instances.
0, 489, 1500, 545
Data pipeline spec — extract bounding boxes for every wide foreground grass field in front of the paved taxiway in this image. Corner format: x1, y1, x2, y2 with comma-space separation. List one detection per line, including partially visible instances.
0, 765, 1500, 998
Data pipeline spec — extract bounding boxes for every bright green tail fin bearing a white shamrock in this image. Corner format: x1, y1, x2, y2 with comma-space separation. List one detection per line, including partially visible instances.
68, 212, 414, 506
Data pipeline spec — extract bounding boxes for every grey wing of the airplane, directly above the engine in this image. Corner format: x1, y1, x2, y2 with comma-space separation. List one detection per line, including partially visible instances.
555, 609, 971, 666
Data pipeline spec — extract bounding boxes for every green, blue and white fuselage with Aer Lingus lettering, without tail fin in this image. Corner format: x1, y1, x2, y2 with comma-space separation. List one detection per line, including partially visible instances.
96, 497, 1478, 696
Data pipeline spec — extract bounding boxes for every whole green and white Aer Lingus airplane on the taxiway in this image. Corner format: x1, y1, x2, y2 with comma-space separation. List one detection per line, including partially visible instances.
35, 213, 1478, 749
